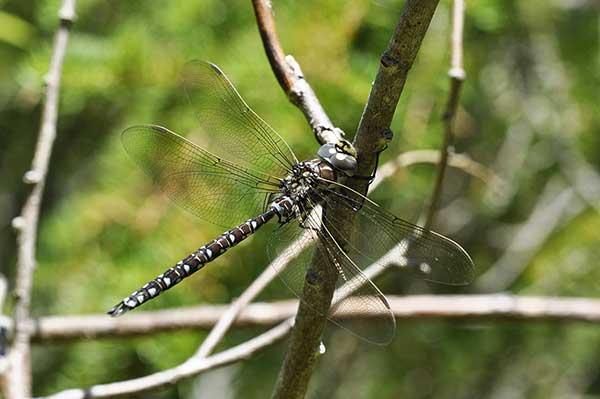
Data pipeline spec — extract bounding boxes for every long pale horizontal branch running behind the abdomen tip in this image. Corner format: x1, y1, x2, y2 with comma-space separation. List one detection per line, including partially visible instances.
27, 294, 600, 342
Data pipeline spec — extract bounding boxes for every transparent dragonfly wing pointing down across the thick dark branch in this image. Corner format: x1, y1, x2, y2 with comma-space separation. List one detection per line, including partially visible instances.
268, 205, 396, 345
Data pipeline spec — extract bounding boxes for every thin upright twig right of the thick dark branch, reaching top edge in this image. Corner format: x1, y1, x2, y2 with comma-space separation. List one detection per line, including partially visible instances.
425, 0, 465, 229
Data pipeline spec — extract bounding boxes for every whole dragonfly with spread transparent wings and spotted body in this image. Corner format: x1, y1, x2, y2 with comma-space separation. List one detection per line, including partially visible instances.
108, 61, 474, 344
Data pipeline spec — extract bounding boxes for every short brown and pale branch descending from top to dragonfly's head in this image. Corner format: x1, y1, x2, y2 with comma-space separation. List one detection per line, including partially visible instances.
252, 0, 350, 145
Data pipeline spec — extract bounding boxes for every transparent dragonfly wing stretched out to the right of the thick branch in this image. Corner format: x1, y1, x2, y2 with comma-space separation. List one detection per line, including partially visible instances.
316, 186, 475, 285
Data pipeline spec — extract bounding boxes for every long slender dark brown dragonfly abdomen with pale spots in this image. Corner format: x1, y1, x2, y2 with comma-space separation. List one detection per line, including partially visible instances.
107, 202, 291, 317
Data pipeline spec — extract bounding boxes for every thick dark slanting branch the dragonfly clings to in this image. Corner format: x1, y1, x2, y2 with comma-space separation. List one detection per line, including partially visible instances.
272, 0, 438, 399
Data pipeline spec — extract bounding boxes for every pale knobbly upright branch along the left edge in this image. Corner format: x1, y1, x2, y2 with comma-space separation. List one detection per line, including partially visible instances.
3, 0, 75, 398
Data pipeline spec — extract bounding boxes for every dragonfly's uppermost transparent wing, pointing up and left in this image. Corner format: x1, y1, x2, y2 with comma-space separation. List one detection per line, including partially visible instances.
182, 61, 298, 176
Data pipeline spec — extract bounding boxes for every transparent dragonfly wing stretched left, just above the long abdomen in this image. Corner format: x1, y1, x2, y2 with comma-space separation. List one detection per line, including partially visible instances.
122, 125, 279, 228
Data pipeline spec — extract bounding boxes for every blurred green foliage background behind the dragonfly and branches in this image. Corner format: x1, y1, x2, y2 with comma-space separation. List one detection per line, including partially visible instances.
0, 0, 600, 398
